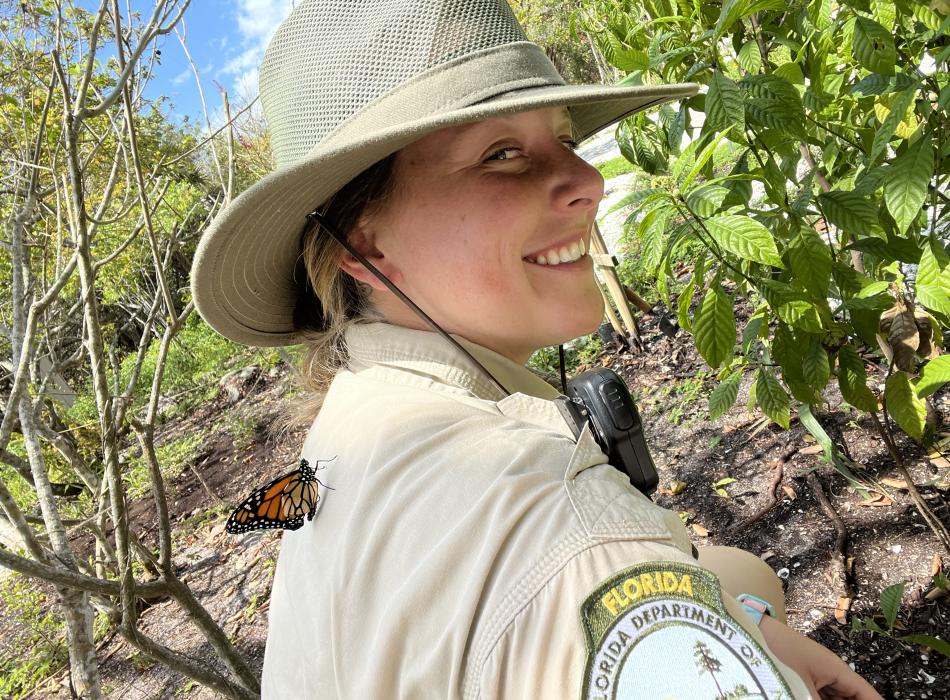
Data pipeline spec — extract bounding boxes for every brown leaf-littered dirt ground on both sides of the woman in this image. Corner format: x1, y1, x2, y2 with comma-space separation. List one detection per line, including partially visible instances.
7, 317, 950, 699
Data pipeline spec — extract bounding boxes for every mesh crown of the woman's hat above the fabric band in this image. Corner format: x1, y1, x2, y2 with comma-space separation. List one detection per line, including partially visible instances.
260, 0, 527, 167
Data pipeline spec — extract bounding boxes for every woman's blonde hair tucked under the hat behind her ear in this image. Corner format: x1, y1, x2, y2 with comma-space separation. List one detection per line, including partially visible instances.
294, 154, 396, 422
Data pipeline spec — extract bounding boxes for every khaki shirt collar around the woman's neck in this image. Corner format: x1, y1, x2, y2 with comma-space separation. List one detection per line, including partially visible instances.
346, 323, 560, 401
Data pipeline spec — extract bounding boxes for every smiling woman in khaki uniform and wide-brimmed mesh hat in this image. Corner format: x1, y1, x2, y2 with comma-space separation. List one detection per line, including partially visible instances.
193, 0, 879, 699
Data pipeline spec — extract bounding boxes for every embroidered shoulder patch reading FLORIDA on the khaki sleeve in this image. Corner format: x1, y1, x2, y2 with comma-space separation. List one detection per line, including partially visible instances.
580, 562, 792, 700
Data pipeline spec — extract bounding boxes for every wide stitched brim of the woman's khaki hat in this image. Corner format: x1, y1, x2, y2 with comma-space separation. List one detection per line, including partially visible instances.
191, 83, 698, 346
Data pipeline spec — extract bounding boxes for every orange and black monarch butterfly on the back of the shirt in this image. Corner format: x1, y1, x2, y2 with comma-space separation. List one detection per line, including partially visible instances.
224, 457, 336, 535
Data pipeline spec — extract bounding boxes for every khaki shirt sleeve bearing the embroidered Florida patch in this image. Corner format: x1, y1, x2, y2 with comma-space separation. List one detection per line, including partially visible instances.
478, 540, 809, 700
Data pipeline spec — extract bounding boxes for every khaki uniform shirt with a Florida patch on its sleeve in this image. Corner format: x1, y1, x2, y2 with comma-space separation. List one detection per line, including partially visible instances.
263, 324, 808, 700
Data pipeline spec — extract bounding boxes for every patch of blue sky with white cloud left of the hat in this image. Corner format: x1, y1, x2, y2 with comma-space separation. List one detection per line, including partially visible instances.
132, 0, 293, 124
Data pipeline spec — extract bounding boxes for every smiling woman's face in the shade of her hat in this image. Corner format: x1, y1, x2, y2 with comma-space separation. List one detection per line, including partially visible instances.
343, 108, 604, 362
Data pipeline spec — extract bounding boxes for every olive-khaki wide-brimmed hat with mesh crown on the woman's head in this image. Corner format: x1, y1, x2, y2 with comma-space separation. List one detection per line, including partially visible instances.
192, 0, 697, 346
